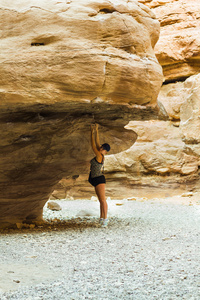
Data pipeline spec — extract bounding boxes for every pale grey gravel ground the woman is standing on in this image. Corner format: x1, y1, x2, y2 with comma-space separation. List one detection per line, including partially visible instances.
0, 197, 200, 300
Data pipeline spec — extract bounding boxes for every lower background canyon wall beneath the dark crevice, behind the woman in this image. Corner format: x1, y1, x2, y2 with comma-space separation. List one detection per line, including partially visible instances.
51, 75, 200, 198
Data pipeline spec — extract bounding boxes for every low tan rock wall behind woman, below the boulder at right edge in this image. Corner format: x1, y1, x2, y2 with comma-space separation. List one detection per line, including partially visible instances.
57, 120, 200, 199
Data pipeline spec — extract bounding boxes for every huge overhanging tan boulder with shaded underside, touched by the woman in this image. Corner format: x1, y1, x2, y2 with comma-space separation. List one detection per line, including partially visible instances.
0, 0, 163, 227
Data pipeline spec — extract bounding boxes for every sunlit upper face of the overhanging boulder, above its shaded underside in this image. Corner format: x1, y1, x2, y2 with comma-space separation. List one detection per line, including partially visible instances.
0, 0, 162, 105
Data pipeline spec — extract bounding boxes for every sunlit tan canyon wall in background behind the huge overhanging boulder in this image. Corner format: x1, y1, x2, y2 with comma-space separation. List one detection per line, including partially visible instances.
56, 0, 200, 202
